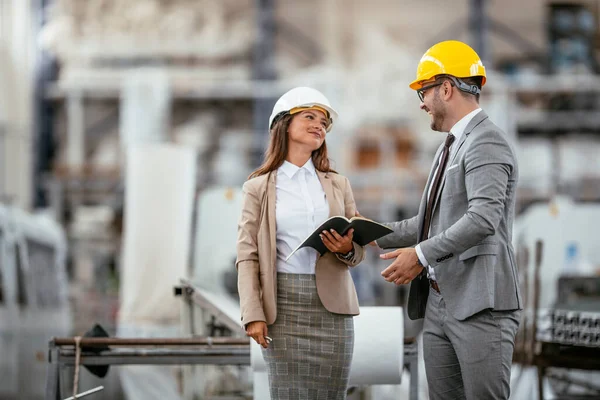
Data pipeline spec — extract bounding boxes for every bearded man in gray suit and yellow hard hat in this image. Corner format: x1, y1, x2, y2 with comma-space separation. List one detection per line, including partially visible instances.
377, 41, 522, 400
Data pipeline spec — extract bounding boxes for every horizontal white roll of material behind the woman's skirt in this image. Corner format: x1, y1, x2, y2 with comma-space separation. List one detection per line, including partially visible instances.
250, 307, 404, 399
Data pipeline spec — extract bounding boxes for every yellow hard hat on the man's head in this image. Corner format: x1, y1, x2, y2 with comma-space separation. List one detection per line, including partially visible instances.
409, 40, 485, 90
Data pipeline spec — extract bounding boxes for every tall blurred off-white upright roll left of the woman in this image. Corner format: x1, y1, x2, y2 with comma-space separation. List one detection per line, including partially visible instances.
119, 144, 196, 325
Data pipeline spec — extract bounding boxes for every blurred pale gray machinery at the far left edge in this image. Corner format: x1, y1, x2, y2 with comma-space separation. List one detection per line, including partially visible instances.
0, 205, 72, 400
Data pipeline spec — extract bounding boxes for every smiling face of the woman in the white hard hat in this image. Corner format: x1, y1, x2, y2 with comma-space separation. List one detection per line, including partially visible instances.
288, 109, 329, 152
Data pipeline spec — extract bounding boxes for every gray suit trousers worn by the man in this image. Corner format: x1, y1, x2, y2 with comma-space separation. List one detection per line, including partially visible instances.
423, 289, 521, 400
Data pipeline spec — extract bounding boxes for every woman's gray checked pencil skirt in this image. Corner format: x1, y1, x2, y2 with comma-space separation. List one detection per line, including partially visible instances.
263, 273, 354, 400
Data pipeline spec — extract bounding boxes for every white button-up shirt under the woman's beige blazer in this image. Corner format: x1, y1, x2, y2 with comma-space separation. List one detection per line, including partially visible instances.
275, 159, 329, 274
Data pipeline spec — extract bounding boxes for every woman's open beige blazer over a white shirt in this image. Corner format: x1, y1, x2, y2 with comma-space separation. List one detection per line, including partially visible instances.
235, 167, 365, 326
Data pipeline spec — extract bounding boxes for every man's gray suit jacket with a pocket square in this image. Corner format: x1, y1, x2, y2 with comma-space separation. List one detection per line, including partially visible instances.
377, 111, 522, 320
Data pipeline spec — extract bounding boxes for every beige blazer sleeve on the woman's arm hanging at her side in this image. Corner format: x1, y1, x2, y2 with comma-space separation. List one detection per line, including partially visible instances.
235, 182, 267, 326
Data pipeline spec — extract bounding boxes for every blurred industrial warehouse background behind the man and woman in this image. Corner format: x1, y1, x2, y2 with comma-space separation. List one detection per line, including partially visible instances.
0, 0, 600, 400
